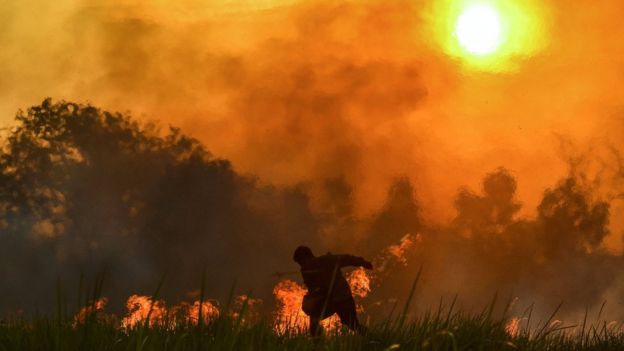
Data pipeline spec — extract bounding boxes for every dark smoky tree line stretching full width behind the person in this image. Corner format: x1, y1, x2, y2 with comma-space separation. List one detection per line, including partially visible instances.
0, 100, 622, 324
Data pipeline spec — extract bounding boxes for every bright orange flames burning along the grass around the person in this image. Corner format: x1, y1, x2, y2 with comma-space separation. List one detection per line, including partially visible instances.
95, 234, 414, 333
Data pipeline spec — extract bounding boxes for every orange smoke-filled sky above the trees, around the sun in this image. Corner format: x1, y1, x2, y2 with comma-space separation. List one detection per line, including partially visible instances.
0, 0, 624, 320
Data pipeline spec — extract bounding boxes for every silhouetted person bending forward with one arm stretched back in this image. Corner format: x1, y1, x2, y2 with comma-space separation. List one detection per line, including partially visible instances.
293, 246, 373, 336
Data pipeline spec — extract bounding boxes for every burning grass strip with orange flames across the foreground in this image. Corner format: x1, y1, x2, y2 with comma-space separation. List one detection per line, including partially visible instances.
6, 235, 624, 351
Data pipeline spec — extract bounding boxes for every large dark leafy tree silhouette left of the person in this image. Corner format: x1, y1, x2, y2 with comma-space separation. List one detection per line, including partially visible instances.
0, 99, 317, 314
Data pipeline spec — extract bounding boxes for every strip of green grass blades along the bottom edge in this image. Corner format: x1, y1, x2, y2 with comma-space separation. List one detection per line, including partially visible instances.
0, 308, 624, 351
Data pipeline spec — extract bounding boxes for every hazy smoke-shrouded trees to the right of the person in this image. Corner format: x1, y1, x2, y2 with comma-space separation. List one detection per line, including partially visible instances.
366, 168, 623, 324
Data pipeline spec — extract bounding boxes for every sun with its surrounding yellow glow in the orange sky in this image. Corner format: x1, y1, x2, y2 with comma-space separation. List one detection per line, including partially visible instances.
421, 0, 553, 72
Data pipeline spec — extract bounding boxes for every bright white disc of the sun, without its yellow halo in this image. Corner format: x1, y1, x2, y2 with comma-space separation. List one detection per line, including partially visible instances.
455, 4, 502, 56
